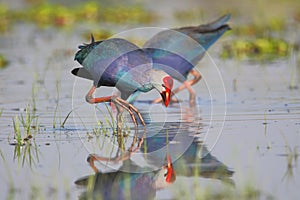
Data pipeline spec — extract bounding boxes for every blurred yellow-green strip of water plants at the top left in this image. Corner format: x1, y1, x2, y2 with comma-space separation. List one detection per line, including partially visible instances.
0, 1, 154, 29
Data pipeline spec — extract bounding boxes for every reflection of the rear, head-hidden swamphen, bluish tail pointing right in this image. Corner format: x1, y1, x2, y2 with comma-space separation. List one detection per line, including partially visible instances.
140, 126, 234, 186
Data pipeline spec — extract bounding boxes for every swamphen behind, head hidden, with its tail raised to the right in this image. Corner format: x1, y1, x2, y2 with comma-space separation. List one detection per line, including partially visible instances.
143, 14, 230, 105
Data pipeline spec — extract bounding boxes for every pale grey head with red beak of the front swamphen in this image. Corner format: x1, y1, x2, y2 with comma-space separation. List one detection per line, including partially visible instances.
151, 69, 173, 107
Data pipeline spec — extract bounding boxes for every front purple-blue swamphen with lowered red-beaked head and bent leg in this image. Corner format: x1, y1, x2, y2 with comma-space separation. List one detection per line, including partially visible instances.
72, 36, 173, 125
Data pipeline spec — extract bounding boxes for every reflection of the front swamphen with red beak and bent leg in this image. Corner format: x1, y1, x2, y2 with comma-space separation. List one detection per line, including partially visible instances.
75, 134, 176, 199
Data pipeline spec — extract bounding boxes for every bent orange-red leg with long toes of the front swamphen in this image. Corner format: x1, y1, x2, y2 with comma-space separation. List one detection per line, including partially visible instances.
85, 86, 146, 126
